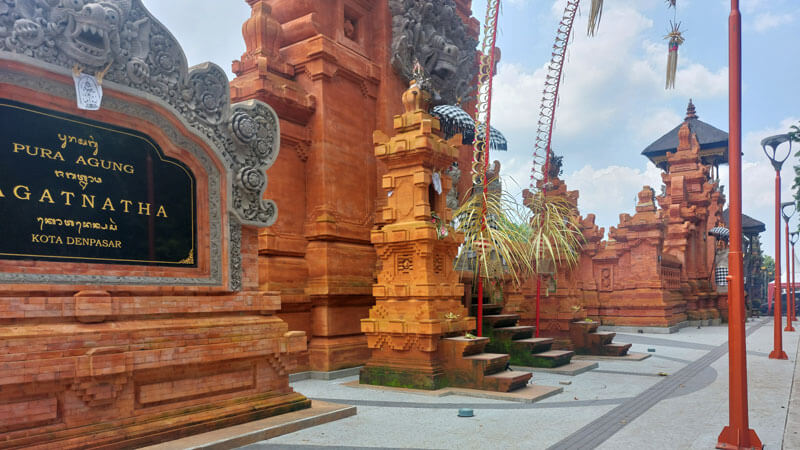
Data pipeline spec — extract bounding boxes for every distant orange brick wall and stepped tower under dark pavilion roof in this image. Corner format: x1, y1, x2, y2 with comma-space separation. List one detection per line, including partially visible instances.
504, 101, 764, 347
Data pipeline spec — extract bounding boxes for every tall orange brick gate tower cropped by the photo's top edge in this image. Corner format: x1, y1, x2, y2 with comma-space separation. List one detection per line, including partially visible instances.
231, 0, 478, 371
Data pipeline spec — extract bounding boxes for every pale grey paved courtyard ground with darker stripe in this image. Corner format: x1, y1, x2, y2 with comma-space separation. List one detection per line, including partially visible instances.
148, 318, 800, 450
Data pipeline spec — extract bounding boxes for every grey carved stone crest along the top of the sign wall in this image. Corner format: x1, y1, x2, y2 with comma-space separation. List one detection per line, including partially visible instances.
0, 0, 280, 226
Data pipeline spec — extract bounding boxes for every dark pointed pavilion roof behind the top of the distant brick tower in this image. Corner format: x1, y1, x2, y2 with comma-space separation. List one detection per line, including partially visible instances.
642, 99, 728, 169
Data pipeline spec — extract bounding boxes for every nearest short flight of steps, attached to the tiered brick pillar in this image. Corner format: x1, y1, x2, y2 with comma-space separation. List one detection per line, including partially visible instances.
439, 336, 532, 392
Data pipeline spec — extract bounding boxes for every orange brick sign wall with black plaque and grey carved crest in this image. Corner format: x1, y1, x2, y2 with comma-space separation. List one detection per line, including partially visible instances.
0, 0, 310, 448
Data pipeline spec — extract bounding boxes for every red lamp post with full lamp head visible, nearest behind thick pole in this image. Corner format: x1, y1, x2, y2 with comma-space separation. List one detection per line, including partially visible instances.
761, 134, 792, 359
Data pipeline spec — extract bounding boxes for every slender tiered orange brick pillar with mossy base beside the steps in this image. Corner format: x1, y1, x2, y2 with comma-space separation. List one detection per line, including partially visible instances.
361, 83, 475, 389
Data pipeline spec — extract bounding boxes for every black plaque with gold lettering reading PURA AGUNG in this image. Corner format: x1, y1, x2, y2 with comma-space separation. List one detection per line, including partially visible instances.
0, 99, 197, 267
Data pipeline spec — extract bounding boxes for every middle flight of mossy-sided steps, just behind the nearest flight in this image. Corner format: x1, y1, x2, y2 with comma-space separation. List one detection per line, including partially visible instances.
483, 312, 575, 368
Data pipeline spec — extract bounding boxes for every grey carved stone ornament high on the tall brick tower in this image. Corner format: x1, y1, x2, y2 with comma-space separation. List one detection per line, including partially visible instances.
389, 0, 478, 105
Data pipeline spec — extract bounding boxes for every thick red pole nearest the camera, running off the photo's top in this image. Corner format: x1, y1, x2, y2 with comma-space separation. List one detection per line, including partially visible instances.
717, 0, 763, 449
